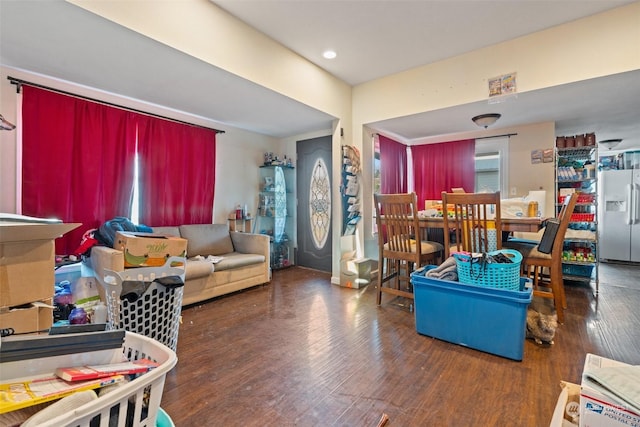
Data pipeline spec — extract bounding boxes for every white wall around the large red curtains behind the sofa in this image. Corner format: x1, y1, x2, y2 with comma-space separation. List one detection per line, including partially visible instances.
0, 67, 278, 223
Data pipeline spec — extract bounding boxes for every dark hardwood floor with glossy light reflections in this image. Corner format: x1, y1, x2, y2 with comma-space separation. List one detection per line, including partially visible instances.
162, 264, 640, 427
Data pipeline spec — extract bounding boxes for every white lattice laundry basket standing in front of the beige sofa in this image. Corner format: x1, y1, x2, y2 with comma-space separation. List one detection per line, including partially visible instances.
101, 257, 186, 351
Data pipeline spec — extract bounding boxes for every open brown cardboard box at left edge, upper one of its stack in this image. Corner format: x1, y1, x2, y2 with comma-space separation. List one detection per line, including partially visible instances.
0, 222, 81, 307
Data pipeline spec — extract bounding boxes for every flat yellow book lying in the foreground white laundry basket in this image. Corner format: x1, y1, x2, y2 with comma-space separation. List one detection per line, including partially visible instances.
0, 374, 124, 414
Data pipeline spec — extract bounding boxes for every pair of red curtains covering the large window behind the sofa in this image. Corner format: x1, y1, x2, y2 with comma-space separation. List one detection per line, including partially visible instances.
19, 84, 216, 254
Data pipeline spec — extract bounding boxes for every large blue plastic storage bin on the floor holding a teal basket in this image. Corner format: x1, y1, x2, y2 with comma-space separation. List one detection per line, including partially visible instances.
411, 266, 532, 360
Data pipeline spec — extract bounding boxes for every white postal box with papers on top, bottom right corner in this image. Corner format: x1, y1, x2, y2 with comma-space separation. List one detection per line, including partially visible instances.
580, 354, 640, 427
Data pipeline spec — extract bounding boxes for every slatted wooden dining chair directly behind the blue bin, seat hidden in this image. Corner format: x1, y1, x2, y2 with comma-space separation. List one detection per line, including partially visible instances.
442, 191, 502, 258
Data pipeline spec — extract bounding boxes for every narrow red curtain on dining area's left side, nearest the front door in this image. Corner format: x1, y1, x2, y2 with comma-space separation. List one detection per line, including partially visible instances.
378, 135, 407, 194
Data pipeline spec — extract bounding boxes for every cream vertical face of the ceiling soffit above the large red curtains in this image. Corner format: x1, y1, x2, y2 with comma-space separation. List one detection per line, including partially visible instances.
69, 0, 351, 135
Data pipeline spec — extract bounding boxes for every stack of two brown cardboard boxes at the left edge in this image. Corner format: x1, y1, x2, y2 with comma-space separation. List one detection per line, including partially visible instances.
0, 221, 81, 333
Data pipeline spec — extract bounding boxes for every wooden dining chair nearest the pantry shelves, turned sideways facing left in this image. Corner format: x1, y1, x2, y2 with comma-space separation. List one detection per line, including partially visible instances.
509, 193, 578, 323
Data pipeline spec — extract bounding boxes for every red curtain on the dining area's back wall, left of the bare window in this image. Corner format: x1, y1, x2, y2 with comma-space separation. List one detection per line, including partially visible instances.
411, 139, 475, 205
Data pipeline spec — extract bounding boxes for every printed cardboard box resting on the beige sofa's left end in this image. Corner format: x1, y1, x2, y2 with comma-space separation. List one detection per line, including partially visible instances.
113, 231, 187, 267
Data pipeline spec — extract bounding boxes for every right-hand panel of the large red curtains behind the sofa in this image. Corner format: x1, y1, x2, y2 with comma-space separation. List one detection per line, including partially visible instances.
138, 117, 216, 227
